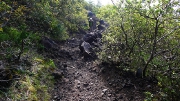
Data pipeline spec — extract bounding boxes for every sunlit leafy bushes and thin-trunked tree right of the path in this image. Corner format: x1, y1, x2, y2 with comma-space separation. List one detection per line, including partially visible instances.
97, 0, 180, 101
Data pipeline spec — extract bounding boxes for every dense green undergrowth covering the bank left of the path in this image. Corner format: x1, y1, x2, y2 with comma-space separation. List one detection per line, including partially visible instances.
0, 0, 91, 101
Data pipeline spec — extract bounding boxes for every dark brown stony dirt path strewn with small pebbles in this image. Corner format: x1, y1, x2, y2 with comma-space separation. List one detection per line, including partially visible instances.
44, 33, 158, 101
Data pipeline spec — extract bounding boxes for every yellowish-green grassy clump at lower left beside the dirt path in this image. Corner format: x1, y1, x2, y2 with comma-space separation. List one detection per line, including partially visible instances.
8, 57, 56, 101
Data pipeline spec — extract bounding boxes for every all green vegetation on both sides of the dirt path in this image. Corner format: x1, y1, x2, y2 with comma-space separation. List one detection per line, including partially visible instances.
0, 0, 180, 101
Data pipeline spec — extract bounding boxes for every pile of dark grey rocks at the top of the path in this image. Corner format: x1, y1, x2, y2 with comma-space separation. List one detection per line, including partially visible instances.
79, 12, 109, 58
